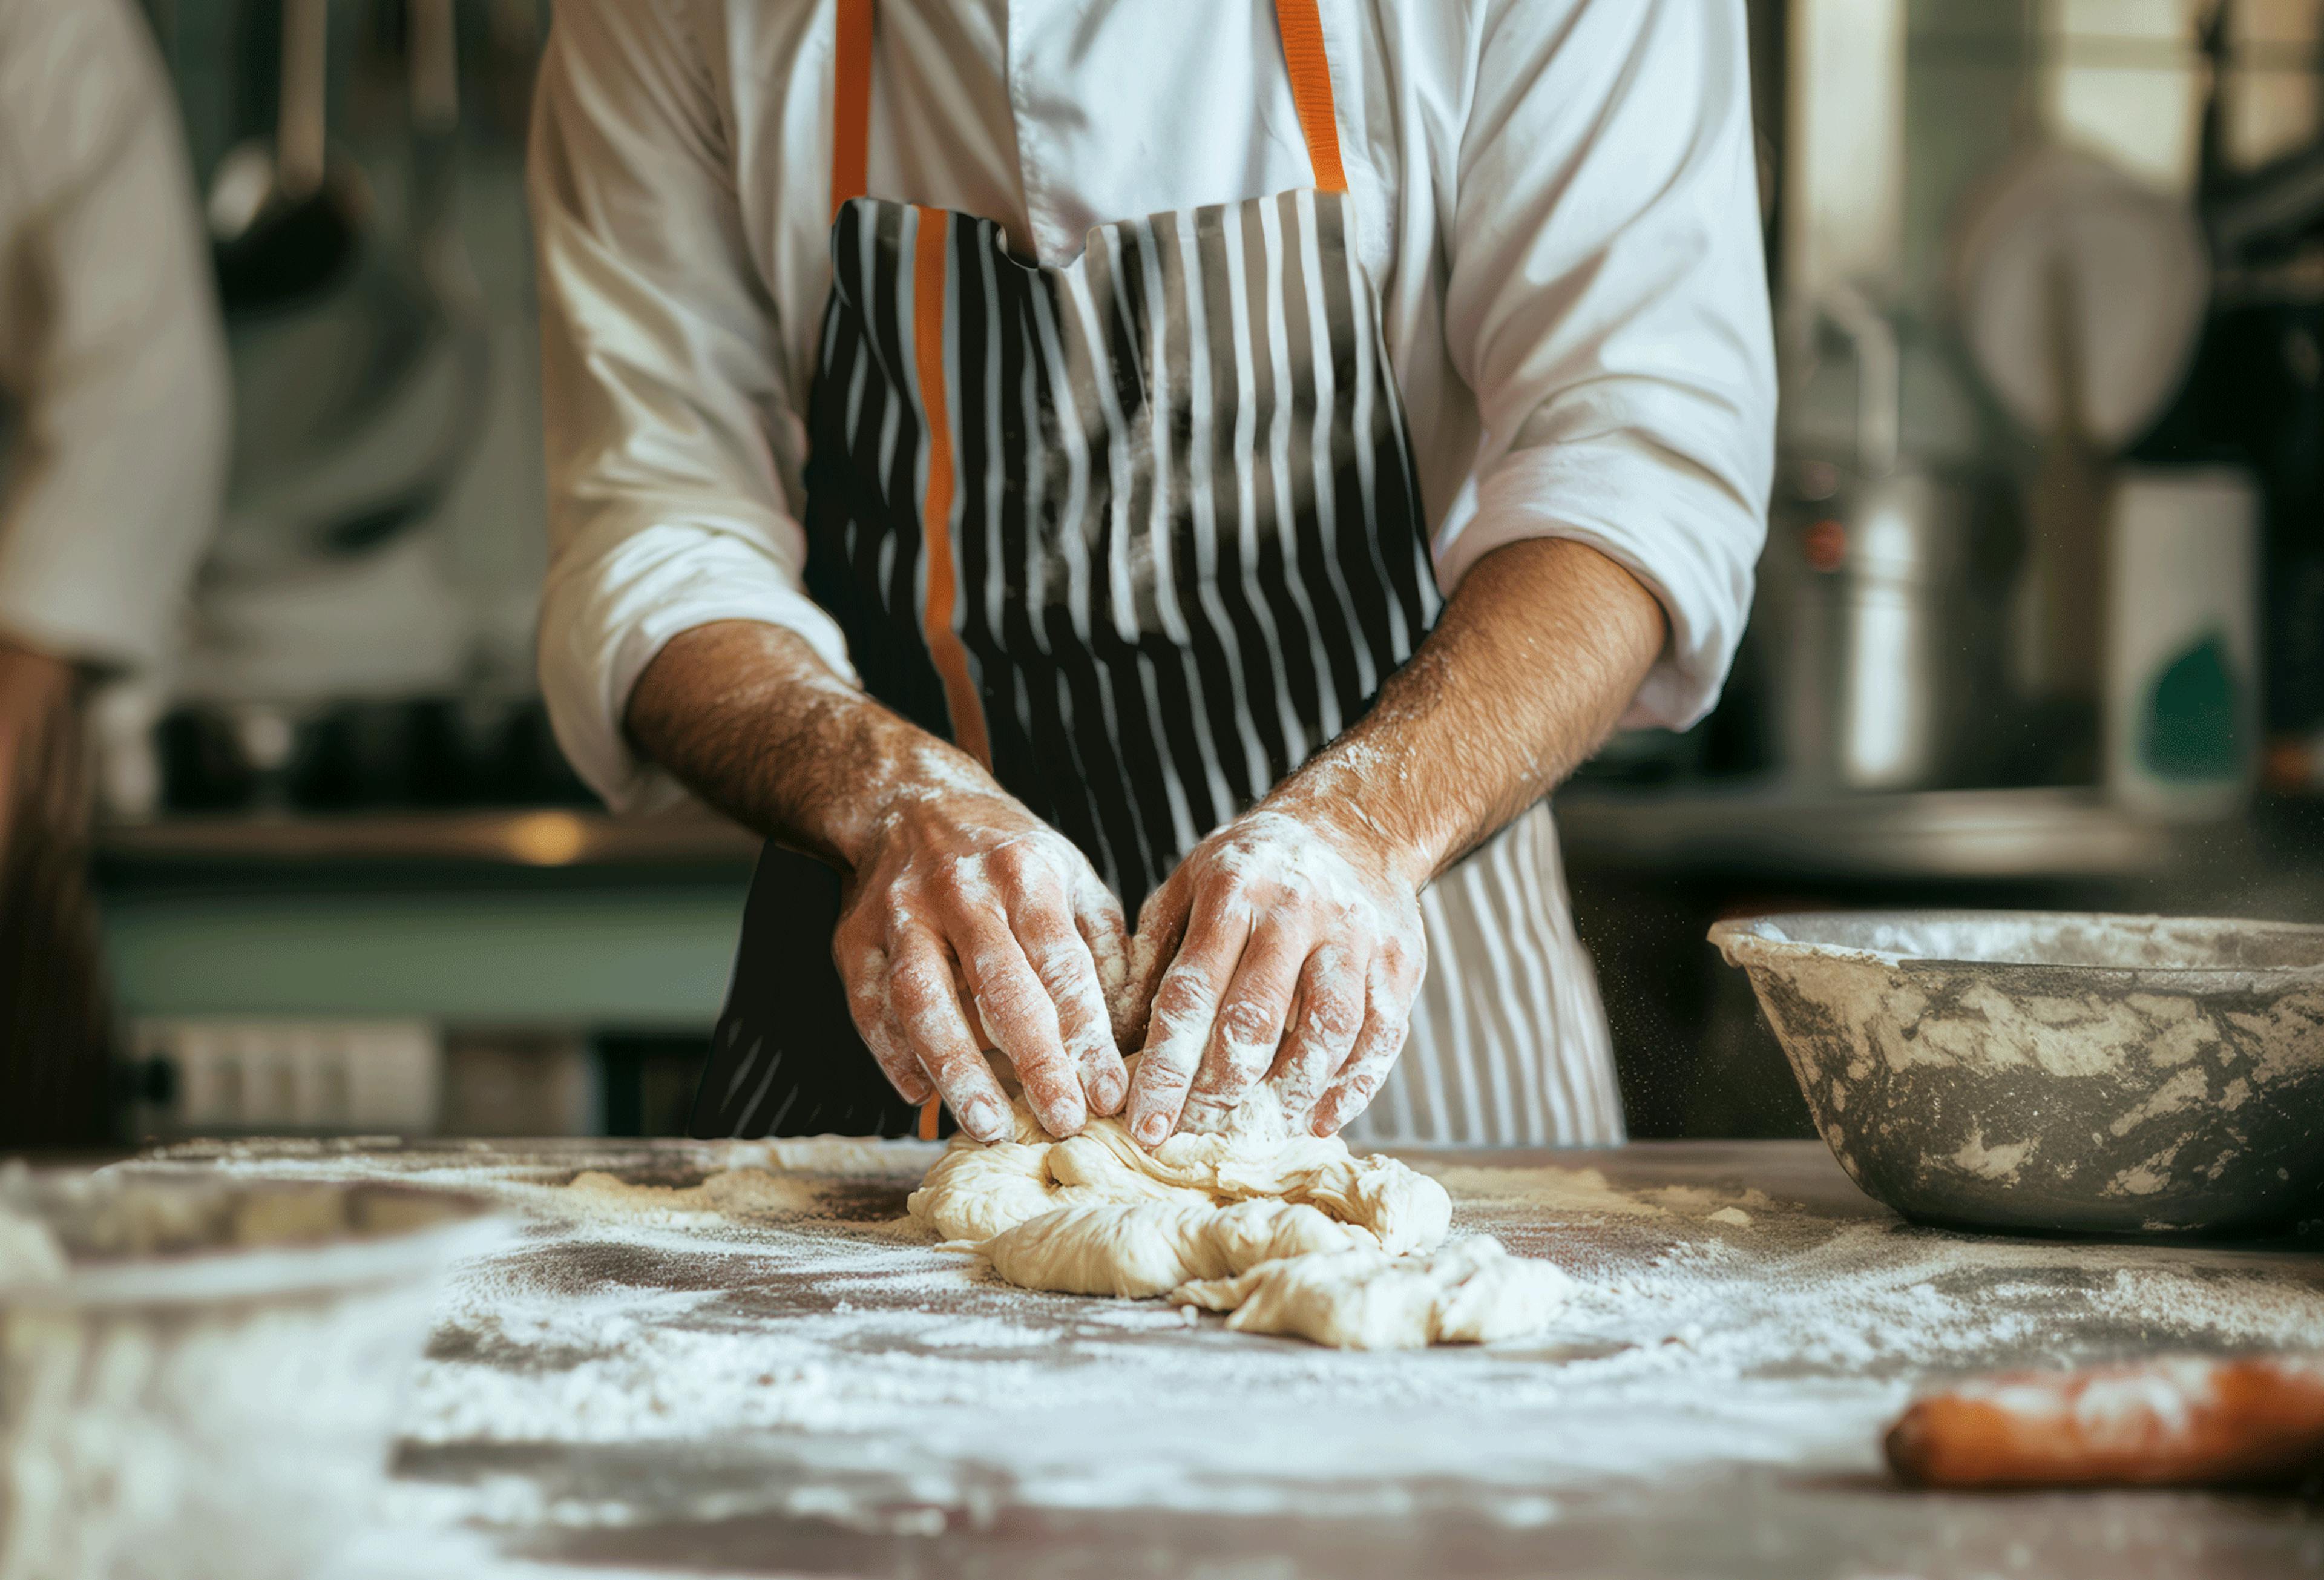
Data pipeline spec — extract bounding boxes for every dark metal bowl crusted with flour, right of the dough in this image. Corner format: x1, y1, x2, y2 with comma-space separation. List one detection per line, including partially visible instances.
1710, 911, 2324, 1234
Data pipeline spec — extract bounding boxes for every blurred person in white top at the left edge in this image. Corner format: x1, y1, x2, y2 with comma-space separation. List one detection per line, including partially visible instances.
0, 0, 228, 1148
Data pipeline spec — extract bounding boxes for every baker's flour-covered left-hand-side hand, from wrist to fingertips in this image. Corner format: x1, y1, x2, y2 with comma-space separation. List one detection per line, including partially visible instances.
832, 767, 1129, 1141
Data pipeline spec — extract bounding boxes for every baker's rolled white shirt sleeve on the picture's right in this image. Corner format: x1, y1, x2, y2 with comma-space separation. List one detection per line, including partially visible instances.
1436, 0, 1776, 729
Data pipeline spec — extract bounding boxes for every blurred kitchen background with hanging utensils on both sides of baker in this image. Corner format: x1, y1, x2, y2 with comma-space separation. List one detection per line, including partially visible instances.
82, 0, 2324, 1136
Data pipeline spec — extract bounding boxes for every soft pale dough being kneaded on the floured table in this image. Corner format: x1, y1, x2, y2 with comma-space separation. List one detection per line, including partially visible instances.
907, 1092, 1571, 1350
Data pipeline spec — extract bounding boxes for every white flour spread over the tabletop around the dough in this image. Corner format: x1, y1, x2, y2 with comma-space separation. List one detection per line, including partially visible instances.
140, 1143, 2324, 1524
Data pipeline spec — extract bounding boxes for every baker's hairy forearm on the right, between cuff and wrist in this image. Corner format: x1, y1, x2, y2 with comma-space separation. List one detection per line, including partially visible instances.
1269, 539, 1664, 883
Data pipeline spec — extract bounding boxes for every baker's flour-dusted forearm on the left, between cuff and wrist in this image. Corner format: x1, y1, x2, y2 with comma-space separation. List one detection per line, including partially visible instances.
625, 620, 997, 869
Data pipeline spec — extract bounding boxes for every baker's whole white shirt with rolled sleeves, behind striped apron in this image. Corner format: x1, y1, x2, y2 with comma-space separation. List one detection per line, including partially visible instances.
530, 0, 1776, 806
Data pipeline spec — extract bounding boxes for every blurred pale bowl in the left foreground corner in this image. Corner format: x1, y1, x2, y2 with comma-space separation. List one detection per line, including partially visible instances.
0, 1169, 504, 1580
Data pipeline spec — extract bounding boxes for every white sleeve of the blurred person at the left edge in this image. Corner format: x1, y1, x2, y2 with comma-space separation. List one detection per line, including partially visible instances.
0, 0, 230, 669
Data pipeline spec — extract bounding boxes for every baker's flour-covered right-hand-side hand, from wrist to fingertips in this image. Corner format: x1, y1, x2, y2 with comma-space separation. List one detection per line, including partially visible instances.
1129, 797, 1427, 1145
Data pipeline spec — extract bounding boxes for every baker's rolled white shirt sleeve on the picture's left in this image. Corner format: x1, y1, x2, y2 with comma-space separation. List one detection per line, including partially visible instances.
530, 0, 853, 809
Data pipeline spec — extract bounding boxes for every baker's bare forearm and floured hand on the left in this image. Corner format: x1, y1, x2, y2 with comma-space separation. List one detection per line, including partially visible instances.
628, 620, 1129, 1141
